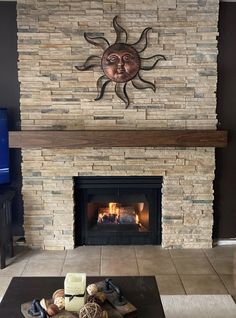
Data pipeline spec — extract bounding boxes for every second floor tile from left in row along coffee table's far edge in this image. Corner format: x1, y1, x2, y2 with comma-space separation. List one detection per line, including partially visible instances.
22, 256, 63, 276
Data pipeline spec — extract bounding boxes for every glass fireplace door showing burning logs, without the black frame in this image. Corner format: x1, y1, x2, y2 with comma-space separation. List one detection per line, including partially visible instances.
87, 190, 149, 231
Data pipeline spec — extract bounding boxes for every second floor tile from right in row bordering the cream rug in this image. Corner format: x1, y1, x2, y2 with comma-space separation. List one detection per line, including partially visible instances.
180, 275, 228, 295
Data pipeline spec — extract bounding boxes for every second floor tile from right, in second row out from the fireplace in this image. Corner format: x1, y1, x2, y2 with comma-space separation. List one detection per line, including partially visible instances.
173, 257, 215, 275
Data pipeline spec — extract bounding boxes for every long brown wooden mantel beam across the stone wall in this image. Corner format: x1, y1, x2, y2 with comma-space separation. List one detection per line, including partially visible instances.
9, 130, 227, 148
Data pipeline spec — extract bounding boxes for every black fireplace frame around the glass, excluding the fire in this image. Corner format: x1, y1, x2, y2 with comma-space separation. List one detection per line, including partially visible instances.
74, 176, 163, 246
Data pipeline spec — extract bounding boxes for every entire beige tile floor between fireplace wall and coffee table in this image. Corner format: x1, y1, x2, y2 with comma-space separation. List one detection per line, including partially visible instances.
0, 246, 236, 298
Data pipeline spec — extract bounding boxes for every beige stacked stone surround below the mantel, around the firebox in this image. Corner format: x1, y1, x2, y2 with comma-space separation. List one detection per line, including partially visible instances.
23, 148, 214, 249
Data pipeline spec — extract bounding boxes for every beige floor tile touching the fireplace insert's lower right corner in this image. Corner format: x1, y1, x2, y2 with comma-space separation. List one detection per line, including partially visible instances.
135, 245, 170, 259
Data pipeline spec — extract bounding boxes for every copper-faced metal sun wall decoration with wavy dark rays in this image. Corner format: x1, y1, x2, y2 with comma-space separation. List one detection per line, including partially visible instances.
76, 16, 166, 108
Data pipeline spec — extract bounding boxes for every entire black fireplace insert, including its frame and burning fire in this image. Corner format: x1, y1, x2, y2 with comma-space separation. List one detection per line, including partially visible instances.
74, 176, 162, 246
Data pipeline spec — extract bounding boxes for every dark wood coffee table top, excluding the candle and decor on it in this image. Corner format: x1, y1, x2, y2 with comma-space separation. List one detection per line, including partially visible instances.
0, 276, 165, 318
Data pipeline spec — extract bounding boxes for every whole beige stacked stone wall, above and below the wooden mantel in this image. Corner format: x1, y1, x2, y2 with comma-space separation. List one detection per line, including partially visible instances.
17, 0, 219, 249
